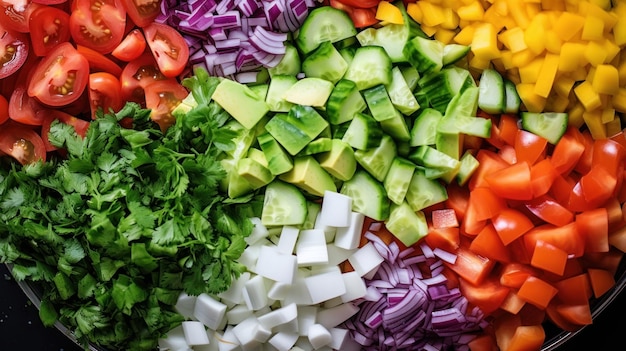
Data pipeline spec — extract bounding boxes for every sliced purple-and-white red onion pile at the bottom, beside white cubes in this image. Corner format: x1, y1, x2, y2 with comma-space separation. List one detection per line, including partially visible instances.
342, 238, 488, 350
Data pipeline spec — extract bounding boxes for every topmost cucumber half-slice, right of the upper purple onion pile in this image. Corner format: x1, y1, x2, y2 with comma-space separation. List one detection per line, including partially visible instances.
296, 6, 357, 55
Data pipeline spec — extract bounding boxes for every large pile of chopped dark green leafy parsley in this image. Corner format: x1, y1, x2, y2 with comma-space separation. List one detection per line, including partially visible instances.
0, 71, 262, 350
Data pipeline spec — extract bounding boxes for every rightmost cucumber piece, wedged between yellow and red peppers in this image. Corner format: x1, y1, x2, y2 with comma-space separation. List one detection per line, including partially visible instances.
521, 111, 568, 145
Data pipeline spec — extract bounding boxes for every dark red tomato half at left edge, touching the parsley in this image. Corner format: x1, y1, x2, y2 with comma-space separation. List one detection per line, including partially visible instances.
0, 123, 46, 165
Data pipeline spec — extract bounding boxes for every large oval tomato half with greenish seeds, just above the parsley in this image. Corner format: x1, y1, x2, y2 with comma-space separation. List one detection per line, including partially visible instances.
28, 42, 89, 106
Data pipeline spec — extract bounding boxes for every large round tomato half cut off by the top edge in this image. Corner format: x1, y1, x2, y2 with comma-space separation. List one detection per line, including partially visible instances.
70, 0, 126, 54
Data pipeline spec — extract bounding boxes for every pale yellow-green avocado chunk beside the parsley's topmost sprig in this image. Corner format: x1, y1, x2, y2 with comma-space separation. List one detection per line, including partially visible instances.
211, 79, 269, 129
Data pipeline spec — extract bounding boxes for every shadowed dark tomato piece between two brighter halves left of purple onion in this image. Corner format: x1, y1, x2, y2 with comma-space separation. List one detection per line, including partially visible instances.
120, 53, 167, 104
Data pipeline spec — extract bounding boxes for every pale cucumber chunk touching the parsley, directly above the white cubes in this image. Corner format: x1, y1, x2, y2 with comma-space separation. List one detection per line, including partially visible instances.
261, 180, 307, 226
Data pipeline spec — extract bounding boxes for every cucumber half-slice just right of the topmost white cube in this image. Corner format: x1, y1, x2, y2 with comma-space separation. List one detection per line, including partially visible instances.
340, 170, 390, 221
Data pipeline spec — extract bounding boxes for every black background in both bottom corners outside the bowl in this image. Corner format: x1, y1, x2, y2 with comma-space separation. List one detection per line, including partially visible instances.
0, 264, 626, 351
